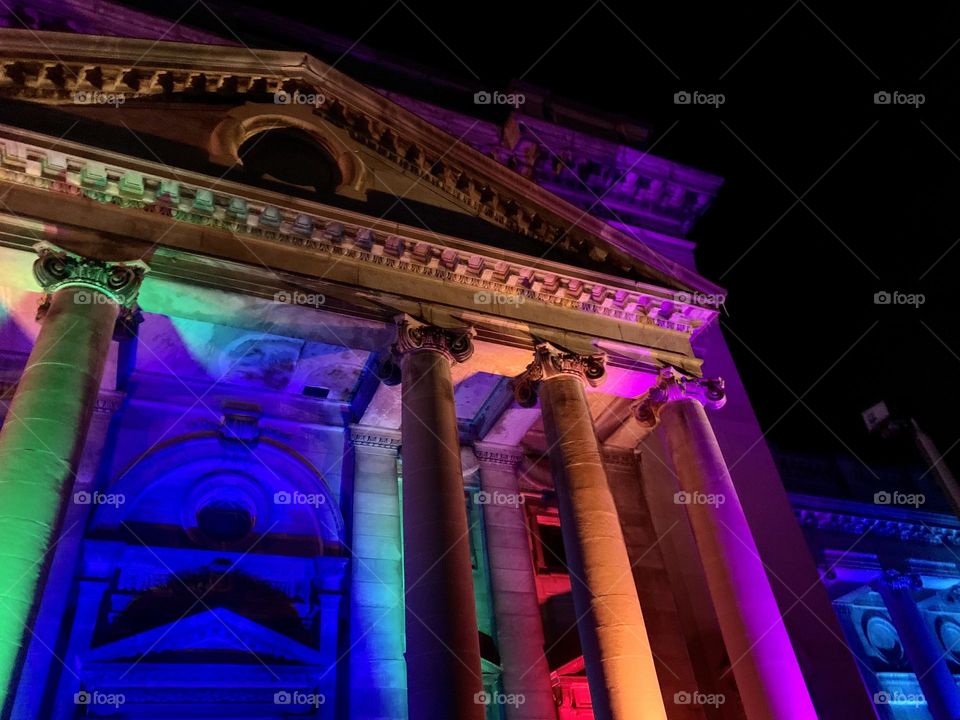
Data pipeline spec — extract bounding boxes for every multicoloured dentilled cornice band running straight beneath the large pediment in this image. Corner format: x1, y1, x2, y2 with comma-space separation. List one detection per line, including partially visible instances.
0, 126, 716, 337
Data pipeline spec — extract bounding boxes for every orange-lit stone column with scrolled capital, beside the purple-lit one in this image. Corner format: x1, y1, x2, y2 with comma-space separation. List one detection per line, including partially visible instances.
514, 343, 667, 720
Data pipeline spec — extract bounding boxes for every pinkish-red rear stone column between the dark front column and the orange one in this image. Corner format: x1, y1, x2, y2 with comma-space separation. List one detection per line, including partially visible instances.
474, 442, 557, 720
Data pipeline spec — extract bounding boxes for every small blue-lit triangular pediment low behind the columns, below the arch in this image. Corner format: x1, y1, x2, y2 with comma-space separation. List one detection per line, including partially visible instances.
86, 608, 322, 665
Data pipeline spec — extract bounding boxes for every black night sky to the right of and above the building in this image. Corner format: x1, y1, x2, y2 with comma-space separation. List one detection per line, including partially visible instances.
124, 0, 960, 473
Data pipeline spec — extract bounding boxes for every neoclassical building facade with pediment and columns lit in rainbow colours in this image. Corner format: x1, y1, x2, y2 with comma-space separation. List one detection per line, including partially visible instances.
0, 3, 936, 720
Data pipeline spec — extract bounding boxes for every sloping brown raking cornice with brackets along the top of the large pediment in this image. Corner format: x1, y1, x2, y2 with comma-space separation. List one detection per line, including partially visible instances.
0, 30, 722, 295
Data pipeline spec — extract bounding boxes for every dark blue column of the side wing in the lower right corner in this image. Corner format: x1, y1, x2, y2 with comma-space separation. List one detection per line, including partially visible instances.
874, 570, 960, 720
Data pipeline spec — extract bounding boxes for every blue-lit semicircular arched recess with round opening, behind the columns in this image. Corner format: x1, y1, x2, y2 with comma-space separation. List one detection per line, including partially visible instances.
91, 431, 344, 555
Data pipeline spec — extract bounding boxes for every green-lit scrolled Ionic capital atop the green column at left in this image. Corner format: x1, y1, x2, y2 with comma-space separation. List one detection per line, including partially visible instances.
33, 242, 149, 308
